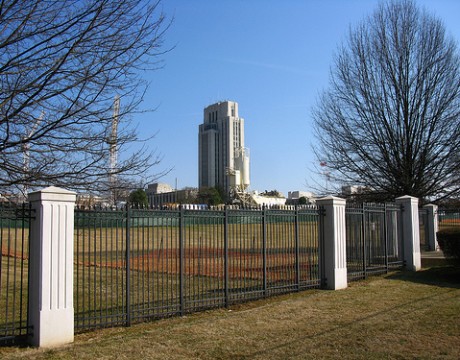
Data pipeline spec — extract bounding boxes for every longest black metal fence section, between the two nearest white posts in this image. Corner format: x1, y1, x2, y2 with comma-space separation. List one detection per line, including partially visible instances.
74, 207, 322, 330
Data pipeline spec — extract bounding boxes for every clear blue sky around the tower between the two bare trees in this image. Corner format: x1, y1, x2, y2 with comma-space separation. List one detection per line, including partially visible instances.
135, 0, 460, 196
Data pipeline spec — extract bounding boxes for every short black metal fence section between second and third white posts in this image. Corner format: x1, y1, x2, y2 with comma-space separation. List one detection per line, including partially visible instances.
345, 204, 403, 281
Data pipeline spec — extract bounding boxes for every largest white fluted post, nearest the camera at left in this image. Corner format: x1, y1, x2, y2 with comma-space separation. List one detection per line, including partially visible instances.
29, 186, 76, 347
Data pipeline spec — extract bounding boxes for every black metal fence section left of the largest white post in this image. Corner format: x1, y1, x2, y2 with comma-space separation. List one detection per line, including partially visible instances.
0, 204, 32, 344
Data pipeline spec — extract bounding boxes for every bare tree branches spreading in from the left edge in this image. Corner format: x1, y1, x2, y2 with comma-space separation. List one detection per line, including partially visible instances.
0, 0, 169, 197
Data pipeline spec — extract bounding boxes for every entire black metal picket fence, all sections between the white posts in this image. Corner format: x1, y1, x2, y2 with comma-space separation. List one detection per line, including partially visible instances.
0, 200, 416, 343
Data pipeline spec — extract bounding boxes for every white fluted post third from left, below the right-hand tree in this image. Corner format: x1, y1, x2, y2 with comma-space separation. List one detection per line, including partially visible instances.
396, 196, 422, 271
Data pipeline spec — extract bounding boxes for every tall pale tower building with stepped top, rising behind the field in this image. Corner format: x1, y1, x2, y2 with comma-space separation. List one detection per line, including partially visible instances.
198, 101, 249, 194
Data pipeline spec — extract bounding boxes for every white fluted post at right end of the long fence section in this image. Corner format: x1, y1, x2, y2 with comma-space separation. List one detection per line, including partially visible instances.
316, 196, 348, 290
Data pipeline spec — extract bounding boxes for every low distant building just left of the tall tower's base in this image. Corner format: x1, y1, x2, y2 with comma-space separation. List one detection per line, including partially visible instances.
146, 183, 198, 207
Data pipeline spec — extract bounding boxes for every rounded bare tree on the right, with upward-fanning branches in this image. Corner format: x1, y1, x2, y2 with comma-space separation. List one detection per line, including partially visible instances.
313, 0, 460, 199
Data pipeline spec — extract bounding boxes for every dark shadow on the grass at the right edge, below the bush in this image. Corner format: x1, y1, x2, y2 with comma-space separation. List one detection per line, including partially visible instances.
386, 261, 460, 289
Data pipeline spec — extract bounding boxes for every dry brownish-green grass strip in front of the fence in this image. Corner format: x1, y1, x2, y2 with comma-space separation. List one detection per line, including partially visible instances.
0, 265, 460, 360
